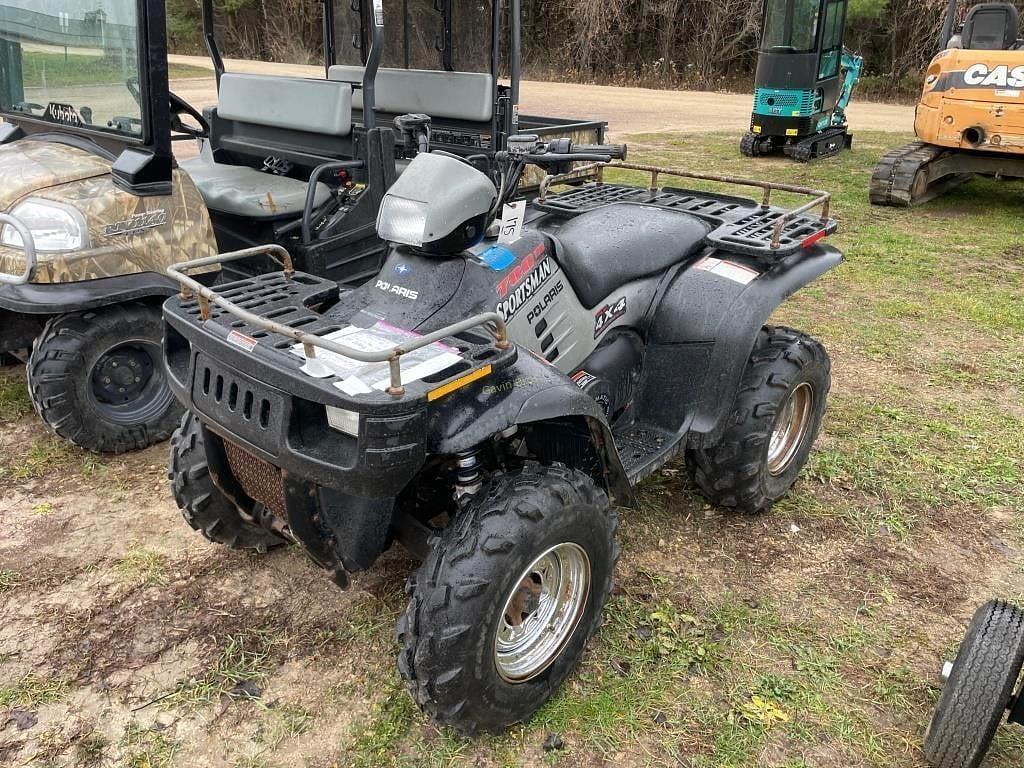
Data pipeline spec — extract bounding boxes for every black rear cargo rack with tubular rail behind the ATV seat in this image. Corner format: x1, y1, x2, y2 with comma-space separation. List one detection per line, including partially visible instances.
535, 162, 838, 258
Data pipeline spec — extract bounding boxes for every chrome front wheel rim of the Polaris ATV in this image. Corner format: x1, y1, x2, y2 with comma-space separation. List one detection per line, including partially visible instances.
495, 543, 591, 683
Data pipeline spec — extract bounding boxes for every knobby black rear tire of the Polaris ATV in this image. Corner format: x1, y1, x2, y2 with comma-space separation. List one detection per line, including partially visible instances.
686, 326, 831, 513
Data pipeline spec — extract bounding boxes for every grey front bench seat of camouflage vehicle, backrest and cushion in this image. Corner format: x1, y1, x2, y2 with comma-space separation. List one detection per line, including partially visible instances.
179, 73, 352, 219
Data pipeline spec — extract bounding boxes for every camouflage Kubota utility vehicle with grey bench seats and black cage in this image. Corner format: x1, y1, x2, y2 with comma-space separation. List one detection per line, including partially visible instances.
0, 0, 604, 452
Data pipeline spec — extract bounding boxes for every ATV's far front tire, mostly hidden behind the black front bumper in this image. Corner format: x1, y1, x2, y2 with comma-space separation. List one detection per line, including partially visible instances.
168, 411, 286, 552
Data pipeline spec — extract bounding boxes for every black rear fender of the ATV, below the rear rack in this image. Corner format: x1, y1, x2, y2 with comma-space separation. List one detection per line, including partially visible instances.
641, 245, 843, 447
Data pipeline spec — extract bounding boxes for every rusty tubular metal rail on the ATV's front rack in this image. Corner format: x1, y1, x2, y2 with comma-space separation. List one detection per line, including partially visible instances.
167, 244, 510, 397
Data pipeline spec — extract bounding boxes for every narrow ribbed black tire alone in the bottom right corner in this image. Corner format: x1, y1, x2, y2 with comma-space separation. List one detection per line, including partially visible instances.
925, 600, 1024, 768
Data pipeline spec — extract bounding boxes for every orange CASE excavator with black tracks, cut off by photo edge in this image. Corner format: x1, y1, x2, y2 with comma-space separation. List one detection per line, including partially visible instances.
870, 0, 1024, 207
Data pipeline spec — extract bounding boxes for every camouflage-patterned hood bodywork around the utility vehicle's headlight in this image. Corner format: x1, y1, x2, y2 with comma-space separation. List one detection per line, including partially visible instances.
0, 139, 217, 284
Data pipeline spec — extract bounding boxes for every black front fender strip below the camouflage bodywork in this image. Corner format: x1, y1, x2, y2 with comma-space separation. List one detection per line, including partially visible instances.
0, 272, 178, 315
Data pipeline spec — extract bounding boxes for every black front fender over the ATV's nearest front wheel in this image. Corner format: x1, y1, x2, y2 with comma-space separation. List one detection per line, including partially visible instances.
426, 349, 633, 505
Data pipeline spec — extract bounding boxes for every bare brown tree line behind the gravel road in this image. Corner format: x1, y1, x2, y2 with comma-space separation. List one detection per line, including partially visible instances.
167, 0, 1024, 97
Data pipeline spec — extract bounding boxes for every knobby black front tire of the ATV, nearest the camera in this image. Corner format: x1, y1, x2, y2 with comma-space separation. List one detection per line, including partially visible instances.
397, 463, 618, 735
